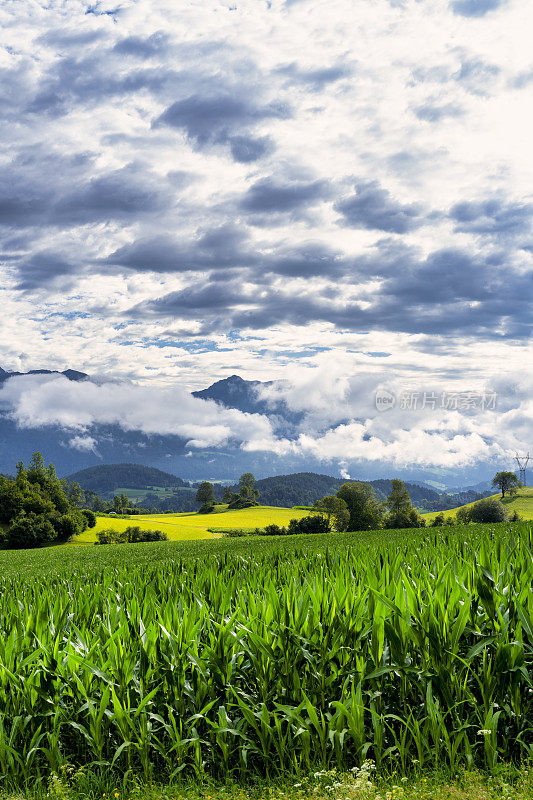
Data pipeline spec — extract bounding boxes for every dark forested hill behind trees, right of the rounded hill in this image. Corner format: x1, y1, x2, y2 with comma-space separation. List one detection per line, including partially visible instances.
256, 472, 441, 507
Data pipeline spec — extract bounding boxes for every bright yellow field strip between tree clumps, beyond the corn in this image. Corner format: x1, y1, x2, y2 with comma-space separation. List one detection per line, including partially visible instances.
73, 506, 309, 545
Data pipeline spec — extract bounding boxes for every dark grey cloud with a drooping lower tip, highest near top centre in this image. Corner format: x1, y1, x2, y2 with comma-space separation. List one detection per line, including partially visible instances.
152, 94, 291, 161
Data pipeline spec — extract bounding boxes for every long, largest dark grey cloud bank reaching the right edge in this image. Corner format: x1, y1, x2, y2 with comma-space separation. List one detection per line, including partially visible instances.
130, 249, 533, 339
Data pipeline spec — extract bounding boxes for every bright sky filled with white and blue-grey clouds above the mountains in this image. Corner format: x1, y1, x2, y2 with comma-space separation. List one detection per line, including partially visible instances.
0, 0, 533, 471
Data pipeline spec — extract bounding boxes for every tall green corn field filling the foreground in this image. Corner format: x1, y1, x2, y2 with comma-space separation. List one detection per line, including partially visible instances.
0, 524, 533, 786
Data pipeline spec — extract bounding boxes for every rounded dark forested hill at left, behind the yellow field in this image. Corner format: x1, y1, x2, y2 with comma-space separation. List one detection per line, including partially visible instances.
67, 464, 189, 494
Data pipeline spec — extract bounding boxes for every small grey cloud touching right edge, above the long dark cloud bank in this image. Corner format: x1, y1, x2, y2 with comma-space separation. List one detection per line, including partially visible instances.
450, 199, 533, 236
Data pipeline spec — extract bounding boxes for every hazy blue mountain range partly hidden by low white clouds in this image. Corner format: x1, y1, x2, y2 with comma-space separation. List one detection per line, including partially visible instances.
0, 367, 498, 488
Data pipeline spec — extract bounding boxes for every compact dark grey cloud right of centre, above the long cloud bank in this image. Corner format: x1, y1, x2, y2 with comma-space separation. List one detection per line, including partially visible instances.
334, 181, 424, 233
